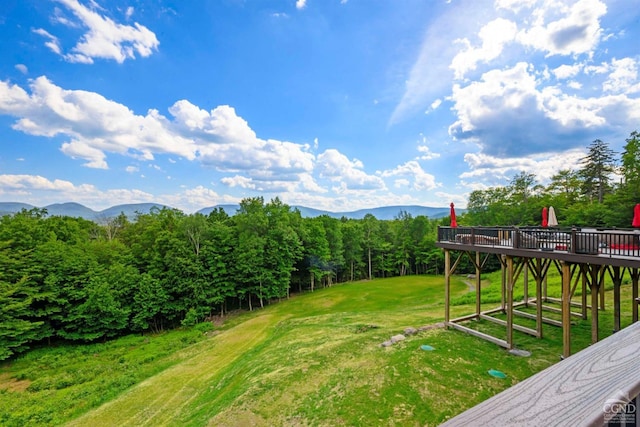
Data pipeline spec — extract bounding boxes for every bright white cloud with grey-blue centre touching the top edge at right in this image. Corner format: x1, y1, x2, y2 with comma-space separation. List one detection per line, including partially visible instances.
517, 0, 607, 56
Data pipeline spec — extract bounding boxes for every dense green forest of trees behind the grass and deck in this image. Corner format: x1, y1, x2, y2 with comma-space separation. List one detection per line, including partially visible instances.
0, 131, 640, 360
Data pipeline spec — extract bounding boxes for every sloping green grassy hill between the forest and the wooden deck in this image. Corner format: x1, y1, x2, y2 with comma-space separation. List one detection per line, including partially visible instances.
0, 276, 629, 426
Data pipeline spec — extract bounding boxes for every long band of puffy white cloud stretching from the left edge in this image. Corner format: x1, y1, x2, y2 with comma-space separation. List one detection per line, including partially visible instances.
0, 77, 338, 192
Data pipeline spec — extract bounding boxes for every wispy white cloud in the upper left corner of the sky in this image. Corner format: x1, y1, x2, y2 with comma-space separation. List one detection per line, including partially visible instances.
44, 0, 159, 64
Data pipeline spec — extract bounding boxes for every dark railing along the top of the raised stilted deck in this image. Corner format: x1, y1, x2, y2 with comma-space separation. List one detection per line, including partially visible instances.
438, 227, 640, 258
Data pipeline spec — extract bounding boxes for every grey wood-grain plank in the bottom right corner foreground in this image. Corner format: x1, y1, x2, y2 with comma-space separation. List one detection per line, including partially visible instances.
443, 322, 640, 427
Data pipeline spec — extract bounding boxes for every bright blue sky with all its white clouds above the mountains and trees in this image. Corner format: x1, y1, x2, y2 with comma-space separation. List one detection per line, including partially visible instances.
0, 0, 640, 213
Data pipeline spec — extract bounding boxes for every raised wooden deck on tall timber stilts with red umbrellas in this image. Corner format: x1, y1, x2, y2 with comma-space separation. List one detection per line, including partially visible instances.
436, 227, 640, 357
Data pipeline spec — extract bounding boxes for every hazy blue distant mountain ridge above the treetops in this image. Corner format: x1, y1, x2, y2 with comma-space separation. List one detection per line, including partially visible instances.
0, 202, 464, 221
